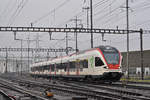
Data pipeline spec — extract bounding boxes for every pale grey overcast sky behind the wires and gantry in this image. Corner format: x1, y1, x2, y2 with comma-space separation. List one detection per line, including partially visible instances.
0, 0, 150, 55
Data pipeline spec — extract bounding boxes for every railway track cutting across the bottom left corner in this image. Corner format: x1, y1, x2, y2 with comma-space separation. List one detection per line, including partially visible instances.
0, 79, 49, 100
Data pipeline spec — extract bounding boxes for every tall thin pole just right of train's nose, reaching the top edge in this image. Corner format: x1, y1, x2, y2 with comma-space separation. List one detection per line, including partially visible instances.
126, 0, 130, 79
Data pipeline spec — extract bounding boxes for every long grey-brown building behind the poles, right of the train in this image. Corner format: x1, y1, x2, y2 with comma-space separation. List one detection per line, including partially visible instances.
121, 50, 150, 76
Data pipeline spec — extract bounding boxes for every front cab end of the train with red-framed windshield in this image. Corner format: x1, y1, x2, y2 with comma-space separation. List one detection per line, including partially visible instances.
98, 46, 123, 82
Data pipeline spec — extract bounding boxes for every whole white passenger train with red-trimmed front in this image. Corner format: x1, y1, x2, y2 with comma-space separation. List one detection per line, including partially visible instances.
31, 46, 123, 82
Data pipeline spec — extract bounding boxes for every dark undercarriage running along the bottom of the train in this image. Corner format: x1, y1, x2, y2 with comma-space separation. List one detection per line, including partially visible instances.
31, 72, 123, 83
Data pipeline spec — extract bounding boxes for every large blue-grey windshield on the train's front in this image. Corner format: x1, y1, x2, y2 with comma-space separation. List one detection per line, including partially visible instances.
104, 53, 119, 65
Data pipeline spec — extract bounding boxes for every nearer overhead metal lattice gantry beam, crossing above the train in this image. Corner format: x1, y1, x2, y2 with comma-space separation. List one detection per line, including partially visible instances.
0, 27, 140, 34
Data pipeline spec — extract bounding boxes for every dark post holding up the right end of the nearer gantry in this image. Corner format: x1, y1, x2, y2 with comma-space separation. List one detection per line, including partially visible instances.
140, 29, 144, 80
